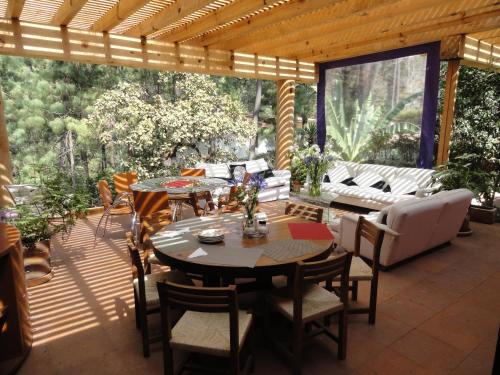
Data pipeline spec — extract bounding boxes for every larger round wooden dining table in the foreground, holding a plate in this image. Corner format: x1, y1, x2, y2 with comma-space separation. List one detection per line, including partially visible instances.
151, 212, 333, 288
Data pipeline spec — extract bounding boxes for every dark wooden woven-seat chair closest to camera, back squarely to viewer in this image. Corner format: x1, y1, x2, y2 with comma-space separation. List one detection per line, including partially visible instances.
158, 281, 254, 375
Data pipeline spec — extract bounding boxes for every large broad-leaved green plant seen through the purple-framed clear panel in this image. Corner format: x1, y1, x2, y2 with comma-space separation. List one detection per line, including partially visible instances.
325, 85, 423, 161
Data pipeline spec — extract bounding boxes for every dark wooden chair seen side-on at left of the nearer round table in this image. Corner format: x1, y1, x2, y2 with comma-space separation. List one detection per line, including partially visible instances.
127, 233, 193, 357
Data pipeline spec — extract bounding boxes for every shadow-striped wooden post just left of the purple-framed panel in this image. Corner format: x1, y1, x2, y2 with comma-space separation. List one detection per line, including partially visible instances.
276, 80, 295, 169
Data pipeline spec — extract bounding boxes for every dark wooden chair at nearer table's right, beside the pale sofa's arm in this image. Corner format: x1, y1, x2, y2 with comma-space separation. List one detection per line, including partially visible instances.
330, 216, 385, 324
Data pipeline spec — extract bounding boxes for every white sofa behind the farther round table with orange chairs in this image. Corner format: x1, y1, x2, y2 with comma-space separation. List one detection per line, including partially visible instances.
196, 159, 291, 202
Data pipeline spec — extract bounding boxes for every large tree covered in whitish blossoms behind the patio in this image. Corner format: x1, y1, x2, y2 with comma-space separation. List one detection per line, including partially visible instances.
88, 73, 256, 177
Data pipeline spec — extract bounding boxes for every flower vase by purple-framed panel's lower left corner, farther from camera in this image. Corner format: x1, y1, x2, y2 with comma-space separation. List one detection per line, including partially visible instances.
303, 145, 334, 197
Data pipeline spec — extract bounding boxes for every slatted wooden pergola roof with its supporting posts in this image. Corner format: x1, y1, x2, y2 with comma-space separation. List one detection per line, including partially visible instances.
0, 0, 500, 206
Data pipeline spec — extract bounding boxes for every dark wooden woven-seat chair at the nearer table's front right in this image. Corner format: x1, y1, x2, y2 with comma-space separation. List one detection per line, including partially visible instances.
265, 253, 352, 374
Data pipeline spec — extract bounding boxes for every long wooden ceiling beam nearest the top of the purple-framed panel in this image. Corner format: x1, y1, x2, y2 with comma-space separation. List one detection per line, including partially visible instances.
300, 11, 500, 62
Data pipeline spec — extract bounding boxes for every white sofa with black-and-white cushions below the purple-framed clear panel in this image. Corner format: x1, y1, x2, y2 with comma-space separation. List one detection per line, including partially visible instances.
305, 161, 434, 210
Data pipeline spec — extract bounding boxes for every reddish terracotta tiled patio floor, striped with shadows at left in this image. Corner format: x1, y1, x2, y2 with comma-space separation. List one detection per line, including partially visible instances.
19, 206, 500, 375
